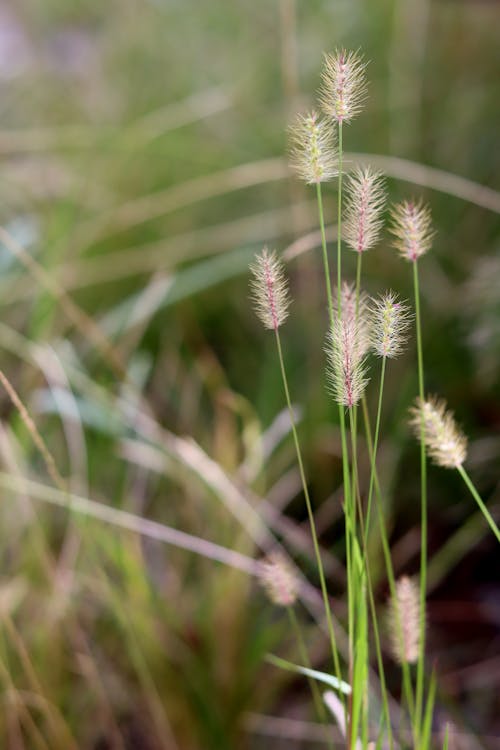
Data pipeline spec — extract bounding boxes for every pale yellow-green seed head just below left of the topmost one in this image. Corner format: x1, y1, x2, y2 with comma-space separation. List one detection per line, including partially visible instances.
290, 111, 337, 185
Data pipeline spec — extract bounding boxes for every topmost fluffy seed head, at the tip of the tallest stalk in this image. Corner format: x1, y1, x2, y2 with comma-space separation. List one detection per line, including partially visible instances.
320, 49, 367, 123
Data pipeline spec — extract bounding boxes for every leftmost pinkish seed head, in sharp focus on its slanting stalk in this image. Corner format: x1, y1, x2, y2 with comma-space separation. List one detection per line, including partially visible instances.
250, 247, 290, 331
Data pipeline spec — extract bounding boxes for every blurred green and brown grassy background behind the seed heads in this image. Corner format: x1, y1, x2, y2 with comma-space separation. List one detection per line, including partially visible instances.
0, 0, 500, 750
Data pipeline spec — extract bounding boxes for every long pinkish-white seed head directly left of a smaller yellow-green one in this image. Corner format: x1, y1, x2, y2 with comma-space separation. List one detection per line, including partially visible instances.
326, 308, 369, 407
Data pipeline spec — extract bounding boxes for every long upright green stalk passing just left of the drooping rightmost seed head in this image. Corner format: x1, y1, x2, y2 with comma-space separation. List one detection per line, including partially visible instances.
413, 261, 427, 735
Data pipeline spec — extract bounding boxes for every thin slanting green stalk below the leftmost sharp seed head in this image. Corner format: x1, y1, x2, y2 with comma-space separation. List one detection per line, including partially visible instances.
275, 328, 341, 692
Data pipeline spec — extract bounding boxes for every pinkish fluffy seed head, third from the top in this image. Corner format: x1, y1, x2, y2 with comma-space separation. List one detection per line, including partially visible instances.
343, 167, 385, 253
